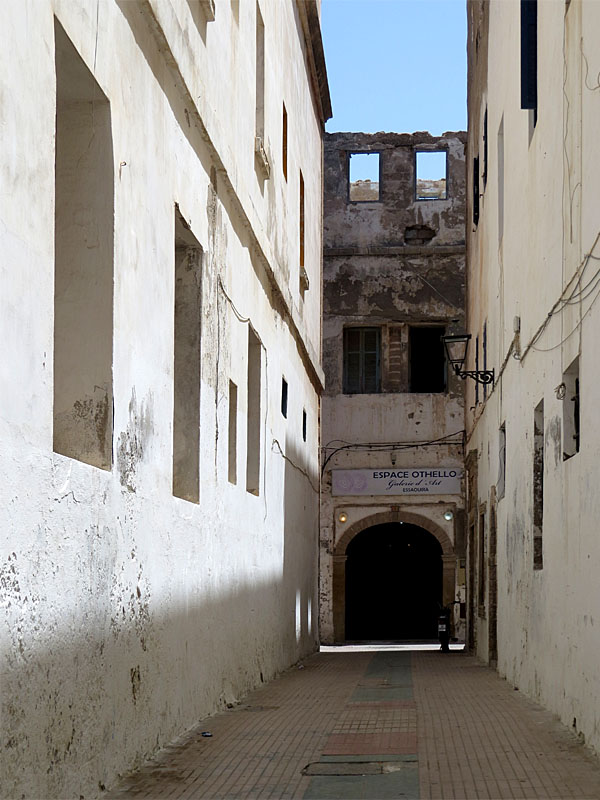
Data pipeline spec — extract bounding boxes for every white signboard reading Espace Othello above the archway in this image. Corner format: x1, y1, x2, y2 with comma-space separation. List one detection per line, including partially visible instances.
332, 467, 463, 496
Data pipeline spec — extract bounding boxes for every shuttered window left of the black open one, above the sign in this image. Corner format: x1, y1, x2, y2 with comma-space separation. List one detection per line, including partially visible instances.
343, 328, 381, 394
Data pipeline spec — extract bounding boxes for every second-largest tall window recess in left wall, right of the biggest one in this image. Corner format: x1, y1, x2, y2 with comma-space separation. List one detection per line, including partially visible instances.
173, 207, 202, 503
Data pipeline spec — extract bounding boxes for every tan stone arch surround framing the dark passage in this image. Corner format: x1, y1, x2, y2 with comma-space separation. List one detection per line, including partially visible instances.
333, 511, 456, 642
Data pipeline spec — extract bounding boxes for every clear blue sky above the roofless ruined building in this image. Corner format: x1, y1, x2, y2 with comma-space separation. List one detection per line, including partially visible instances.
321, 0, 467, 135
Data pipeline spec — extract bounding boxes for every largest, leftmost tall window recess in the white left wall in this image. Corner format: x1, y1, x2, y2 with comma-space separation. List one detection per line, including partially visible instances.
53, 20, 114, 470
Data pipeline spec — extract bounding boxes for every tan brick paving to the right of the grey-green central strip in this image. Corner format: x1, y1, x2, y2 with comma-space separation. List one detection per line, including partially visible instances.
413, 652, 600, 800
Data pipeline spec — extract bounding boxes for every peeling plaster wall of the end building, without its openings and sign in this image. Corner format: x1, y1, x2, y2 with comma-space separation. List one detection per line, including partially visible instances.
320, 133, 466, 642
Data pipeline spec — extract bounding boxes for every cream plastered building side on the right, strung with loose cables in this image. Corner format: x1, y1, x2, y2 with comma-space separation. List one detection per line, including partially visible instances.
466, 0, 600, 750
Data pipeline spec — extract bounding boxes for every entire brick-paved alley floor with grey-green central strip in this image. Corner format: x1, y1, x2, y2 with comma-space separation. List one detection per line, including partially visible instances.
108, 648, 600, 800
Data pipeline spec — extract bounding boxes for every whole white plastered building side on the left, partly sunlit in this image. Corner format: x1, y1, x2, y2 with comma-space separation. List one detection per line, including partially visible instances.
0, 0, 330, 798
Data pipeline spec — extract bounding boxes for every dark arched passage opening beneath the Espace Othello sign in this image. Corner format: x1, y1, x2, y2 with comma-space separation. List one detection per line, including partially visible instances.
346, 522, 442, 640
